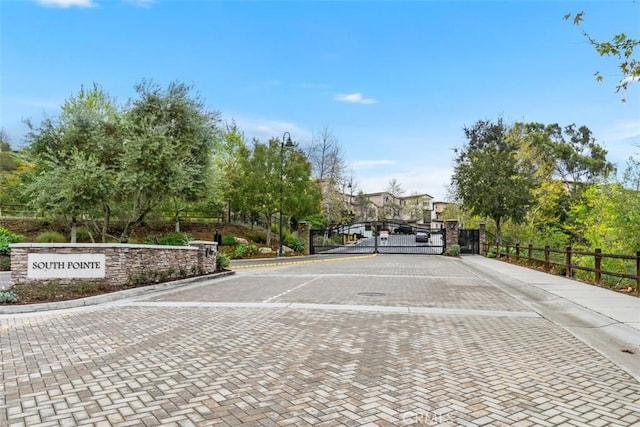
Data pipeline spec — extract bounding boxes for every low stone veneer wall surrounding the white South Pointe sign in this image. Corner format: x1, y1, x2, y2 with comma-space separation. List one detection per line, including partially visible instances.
11, 241, 217, 286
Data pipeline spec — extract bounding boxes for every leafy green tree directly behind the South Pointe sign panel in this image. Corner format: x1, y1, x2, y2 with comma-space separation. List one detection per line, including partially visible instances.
27, 84, 125, 241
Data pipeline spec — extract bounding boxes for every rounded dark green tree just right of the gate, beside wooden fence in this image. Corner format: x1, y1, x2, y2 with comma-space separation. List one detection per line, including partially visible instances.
452, 119, 536, 242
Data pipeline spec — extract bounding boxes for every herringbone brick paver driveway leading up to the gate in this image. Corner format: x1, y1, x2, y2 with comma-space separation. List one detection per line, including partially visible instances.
0, 255, 640, 426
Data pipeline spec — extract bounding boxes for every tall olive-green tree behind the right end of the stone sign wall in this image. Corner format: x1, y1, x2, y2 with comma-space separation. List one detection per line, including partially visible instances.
120, 81, 222, 236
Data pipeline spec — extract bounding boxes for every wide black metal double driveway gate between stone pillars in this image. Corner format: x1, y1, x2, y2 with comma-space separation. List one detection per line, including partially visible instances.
310, 221, 446, 255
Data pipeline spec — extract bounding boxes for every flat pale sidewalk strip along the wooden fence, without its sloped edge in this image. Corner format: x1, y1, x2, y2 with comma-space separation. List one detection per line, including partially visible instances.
464, 255, 640, 330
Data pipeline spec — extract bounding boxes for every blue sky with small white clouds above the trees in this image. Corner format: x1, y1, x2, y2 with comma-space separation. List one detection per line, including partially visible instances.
0, 0, 640, 200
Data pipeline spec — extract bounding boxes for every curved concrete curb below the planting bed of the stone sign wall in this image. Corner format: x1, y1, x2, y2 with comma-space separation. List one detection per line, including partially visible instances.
0, 270, 236, 314
